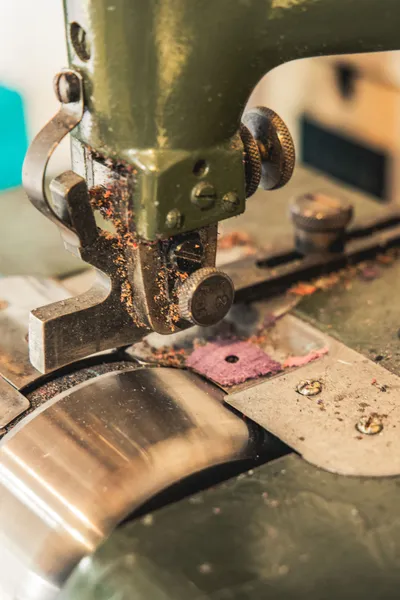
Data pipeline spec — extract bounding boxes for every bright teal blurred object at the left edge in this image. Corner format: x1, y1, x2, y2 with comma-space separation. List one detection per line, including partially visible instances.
0, 85, 28, 191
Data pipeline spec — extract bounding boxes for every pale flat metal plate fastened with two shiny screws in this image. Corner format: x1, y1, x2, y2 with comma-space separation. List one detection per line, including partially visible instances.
226, 315, 400, 476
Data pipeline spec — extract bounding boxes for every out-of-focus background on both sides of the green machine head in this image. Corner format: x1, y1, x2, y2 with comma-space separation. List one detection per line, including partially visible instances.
0, 0, 400, 275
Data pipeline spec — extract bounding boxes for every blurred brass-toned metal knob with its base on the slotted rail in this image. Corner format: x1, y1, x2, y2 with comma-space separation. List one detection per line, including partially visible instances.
290, 193, 353, 254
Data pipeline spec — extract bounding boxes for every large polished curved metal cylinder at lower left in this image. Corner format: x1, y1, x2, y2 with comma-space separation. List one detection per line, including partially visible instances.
0, 368, 249, 600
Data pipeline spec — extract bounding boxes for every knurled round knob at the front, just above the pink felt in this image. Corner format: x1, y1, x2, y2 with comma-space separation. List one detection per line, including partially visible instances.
178, 267, 235, 327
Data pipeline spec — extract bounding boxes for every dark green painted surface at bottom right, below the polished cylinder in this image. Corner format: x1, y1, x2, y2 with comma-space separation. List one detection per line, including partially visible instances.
65, 455, 400, 600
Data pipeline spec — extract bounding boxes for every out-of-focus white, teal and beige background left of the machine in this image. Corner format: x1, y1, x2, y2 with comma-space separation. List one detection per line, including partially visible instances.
0, 0, 79, 275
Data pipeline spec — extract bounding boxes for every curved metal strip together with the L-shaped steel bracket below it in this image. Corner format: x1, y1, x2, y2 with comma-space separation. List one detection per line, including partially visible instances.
23, 70, 148, 373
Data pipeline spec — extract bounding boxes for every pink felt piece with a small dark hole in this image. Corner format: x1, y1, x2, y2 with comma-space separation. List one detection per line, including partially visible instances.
186, 340, 282, 386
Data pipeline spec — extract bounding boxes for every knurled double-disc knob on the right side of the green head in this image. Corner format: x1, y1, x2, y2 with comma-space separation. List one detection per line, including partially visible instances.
243, 106, 296, 190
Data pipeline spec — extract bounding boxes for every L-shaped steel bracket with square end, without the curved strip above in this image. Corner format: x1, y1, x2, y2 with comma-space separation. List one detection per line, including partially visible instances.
29, 171, 147, 373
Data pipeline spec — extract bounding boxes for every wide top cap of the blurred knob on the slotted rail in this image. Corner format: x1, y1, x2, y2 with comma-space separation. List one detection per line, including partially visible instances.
290, 193, 353, 233
